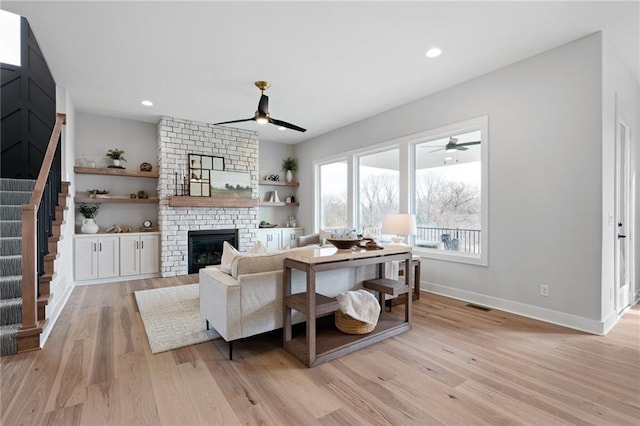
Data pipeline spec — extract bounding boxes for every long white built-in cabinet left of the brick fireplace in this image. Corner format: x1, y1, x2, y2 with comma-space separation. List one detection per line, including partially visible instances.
74, 232, 160, 282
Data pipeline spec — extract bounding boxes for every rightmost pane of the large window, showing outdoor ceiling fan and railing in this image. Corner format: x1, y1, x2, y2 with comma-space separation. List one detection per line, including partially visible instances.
413, 115, 487, 264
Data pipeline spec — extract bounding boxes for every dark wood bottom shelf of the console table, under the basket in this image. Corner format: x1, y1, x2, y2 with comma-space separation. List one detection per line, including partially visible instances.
284, 312, 411, 367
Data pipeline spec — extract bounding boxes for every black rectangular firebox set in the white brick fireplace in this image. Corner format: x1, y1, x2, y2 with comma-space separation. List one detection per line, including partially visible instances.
188, 229, 238, 274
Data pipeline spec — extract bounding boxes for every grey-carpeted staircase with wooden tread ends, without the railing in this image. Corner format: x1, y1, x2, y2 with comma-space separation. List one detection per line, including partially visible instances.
0, 178, 69, 356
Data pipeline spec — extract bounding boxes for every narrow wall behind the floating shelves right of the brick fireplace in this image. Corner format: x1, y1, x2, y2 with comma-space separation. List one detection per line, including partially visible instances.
258, 141, 296, 226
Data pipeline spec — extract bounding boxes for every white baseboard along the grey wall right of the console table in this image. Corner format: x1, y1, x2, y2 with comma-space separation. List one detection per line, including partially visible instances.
421, 281, 617, 335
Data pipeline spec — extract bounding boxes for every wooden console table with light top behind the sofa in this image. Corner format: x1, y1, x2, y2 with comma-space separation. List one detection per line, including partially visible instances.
283, 246, 413, 367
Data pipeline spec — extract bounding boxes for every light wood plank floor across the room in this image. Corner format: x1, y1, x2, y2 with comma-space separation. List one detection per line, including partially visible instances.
0, 275, 640, 425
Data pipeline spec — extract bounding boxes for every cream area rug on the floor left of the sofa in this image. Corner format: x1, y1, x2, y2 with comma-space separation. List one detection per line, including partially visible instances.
135, 284, 220, 354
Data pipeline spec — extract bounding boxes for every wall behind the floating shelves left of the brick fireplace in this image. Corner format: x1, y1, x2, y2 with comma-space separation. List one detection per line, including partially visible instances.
75, 113, 158, 233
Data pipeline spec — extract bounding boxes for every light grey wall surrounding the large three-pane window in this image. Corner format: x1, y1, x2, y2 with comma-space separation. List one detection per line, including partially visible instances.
295, 34, 602, 332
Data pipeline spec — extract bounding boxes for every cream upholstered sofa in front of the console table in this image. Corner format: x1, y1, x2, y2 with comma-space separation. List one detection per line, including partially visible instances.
199, 248, 377, 358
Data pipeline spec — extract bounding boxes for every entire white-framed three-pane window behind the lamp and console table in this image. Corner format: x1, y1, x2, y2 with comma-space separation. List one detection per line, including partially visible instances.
316, 117, 489, 265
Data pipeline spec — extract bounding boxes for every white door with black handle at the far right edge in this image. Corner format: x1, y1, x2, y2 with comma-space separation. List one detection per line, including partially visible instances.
615, 107, 633, 314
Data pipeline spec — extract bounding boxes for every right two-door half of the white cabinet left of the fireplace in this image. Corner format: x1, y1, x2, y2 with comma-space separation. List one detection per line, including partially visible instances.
120, 234, 160, 277
